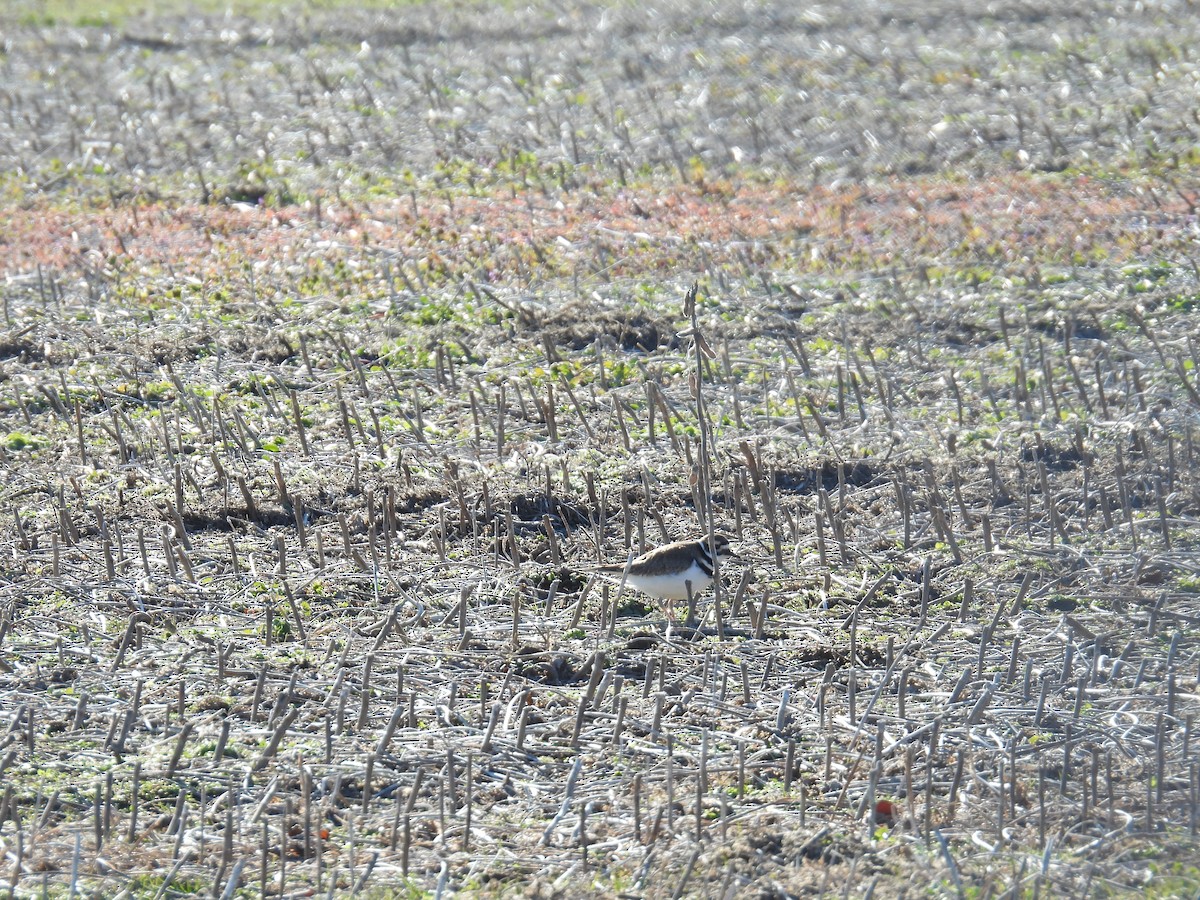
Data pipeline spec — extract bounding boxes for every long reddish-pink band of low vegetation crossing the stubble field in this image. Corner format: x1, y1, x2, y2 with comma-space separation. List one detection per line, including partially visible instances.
0, 175, 1190, 278
